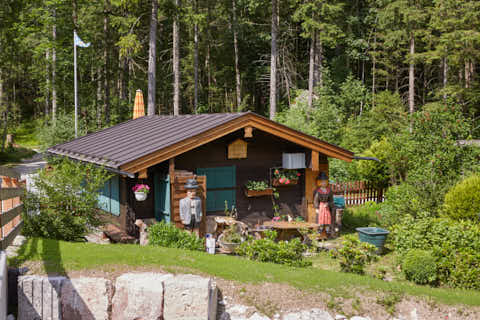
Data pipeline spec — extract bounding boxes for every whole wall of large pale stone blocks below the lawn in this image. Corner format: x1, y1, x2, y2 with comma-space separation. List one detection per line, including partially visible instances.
18, 273, 217, 320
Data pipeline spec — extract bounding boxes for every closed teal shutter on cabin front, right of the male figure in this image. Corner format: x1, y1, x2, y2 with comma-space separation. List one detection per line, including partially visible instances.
197, 166, 236, 212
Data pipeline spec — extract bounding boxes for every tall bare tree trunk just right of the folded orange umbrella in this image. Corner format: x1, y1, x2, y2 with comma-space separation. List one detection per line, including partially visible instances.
147, 0, 158, 116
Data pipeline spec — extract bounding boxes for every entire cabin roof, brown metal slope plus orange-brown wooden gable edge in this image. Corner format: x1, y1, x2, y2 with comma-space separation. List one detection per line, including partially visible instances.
47, 112, 353, 172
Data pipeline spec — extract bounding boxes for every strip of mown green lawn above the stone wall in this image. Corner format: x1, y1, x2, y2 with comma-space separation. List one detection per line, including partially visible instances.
9, 239, 480, 306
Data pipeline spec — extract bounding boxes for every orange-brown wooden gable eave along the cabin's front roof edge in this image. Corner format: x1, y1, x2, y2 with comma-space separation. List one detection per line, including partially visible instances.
120, 114, 353, 173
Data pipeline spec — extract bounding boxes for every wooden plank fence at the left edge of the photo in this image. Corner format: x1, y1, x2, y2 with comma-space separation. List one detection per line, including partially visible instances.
0, 167, 24, 250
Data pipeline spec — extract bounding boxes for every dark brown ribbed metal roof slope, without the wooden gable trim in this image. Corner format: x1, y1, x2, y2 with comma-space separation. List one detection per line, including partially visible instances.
47, 113, 246, 168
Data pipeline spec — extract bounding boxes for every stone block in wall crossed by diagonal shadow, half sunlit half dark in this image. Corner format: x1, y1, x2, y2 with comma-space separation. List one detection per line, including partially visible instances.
60, 278, 113, 320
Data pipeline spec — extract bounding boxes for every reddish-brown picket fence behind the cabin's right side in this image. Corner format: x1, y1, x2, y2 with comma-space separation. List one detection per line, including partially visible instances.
331, 181, 384, 207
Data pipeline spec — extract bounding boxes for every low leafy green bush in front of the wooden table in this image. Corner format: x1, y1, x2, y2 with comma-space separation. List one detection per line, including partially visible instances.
235, 231, 312, 267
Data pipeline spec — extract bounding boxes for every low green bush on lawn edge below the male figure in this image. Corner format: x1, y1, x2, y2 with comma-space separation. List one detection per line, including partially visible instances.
148, 221, 204, 251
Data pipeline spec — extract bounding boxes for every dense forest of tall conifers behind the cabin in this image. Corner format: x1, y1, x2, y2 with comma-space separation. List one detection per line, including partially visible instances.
0, 0, 480, 184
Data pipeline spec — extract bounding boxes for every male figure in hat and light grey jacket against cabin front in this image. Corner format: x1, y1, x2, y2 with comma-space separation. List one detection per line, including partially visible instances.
180, 179, 202, 230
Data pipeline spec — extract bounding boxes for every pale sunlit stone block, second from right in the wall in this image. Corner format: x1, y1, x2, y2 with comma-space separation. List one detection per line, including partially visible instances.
112, 273, 173, 320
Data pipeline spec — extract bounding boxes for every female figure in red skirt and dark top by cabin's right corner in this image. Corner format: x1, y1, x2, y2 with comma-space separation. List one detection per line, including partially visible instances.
313, 172, 333, 238
